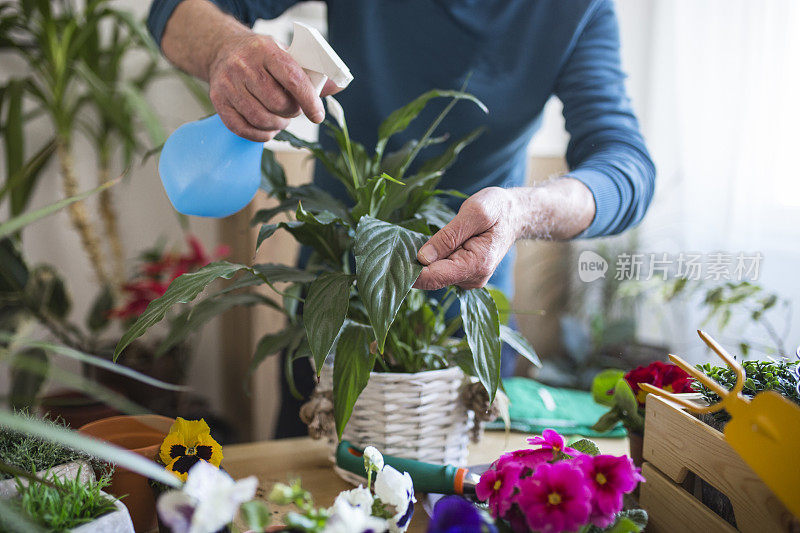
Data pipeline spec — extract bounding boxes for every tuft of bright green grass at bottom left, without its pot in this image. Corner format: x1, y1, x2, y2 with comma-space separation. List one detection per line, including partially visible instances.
17, 470, 116, 531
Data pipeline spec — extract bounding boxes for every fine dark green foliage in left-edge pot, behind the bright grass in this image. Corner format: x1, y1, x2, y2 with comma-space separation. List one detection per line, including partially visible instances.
0, 411, 99, 479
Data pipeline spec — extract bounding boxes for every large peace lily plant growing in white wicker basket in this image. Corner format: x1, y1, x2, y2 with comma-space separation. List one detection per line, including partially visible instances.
114, 90, 538, 438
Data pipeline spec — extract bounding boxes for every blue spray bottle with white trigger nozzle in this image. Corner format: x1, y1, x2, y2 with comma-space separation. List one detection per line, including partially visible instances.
158, 22, 353, 218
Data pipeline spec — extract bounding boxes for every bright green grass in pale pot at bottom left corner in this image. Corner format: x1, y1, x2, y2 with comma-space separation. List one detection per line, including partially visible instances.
6, 470, 134, 533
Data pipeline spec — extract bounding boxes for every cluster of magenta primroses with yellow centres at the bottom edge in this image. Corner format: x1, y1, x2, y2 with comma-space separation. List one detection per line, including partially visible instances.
468, 429, 647, 533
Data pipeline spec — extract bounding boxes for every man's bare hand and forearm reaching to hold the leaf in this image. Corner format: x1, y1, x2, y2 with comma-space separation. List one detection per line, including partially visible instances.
414, 177, 595, 290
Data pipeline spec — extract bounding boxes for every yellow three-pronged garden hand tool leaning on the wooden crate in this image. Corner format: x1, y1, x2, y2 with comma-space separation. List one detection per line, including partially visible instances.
640, 331, 800, 516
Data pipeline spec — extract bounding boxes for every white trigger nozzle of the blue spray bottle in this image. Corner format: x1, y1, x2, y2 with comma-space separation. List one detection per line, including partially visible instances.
287, 22, 353, 94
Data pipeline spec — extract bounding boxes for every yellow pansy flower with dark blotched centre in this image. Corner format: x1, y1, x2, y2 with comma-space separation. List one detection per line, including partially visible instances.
159, 417, 222, 481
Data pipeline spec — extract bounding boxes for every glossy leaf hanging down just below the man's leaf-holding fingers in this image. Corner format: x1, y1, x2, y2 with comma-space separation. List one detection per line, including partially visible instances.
458, 288, 502, 401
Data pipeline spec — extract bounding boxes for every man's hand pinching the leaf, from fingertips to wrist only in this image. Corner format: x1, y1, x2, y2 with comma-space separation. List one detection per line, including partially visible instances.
414, 187, 521, 290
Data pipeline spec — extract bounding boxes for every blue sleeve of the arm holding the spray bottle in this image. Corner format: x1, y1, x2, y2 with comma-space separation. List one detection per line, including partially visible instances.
147, 0, 298, 46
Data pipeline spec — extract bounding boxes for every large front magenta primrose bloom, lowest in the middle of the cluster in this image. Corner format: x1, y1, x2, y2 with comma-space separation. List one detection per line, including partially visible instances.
516, 461, 592, 533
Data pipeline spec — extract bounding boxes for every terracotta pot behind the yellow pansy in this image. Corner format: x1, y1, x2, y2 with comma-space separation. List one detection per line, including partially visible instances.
79, 415, 174, 533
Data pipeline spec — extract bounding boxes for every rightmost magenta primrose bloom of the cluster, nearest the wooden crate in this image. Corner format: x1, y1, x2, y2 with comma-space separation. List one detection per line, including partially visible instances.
574, 455, 644, 527
